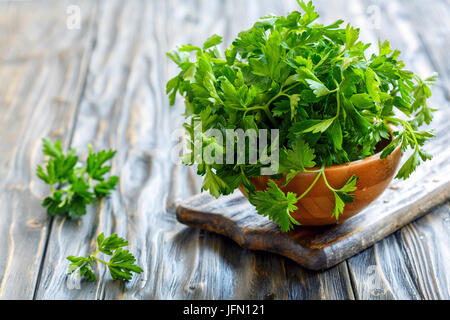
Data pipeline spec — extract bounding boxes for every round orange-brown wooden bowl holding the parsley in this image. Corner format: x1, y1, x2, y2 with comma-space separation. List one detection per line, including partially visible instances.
239, 143, 402, 226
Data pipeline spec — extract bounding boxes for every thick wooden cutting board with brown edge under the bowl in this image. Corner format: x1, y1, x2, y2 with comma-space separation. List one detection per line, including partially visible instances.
177, 180, 450, 270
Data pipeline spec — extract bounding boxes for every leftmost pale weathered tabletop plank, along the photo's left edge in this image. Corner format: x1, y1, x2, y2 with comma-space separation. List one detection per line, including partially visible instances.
0, 1, 96, 299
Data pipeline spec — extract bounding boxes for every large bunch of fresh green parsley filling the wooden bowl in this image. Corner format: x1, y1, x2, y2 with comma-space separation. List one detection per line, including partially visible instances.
167, 1, 436, 231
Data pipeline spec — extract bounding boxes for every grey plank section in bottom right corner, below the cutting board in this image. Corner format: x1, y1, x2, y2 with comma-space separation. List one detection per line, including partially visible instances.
349, 202, 450, 300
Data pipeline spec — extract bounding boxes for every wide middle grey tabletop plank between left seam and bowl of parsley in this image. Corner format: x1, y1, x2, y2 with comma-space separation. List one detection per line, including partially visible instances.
37, 0, 353, 299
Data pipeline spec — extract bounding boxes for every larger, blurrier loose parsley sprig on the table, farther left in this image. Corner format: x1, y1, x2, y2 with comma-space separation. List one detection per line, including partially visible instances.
37, 138, 119, 217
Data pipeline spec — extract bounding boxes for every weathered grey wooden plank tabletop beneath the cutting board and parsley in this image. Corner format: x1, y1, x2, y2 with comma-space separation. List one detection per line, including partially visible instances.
0, 0, 450, 299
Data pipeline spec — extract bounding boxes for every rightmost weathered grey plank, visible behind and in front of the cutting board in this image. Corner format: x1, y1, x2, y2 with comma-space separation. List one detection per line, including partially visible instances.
314, 0, 450, 299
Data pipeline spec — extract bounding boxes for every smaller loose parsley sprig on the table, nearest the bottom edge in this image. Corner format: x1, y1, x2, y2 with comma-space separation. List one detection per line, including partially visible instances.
67, 233, 143, 281
